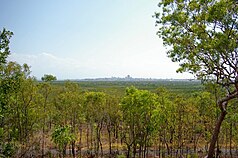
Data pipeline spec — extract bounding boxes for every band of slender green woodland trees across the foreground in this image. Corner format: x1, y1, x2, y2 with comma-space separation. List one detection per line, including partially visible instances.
0, 62, 238, 157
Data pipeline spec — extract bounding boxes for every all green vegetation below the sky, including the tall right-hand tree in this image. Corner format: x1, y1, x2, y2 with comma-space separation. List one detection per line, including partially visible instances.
0, 0, 238, 158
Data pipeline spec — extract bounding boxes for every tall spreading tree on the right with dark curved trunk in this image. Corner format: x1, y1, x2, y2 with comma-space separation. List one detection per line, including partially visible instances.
155, 0, 238, 158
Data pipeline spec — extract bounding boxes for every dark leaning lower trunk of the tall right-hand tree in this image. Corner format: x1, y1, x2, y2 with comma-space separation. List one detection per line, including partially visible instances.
207, 110, 227, 158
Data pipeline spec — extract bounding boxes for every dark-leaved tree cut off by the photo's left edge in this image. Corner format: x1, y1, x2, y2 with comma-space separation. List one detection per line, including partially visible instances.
0, 28, 16, 156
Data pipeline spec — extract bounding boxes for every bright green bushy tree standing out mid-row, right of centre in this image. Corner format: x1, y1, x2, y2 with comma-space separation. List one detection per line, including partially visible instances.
121, 87, 160, 157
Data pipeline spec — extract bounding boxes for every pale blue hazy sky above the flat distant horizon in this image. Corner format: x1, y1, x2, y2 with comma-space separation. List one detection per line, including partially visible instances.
0, 0, 193, 79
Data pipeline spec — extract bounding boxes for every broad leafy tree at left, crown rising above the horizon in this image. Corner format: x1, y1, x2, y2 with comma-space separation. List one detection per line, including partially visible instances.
1, 62, 39, 156
